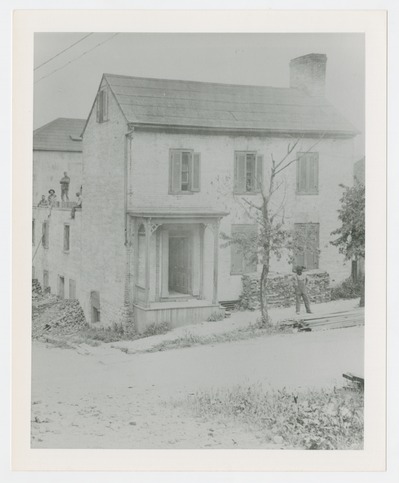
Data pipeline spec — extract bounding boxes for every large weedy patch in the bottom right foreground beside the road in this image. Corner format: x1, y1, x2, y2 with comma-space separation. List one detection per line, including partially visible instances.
180, 385, 364, 450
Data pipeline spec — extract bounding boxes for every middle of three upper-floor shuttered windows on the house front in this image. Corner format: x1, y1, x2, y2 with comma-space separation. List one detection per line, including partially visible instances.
234, 151, 263, 194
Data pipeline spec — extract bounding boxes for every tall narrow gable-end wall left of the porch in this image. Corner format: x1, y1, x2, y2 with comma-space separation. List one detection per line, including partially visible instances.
80, 81, 131, 325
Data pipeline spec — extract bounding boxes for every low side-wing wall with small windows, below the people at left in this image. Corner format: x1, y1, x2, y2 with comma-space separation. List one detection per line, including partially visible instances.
32, 208, 82, 299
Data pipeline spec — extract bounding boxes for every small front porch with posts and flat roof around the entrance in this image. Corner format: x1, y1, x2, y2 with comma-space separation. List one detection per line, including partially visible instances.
129, 208, 227, 331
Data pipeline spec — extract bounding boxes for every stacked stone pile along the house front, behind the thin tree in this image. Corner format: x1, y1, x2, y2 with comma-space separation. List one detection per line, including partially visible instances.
238, 270, 331, 310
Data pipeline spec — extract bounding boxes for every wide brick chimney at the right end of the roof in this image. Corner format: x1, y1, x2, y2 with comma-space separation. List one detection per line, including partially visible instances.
290, 54, 327, 96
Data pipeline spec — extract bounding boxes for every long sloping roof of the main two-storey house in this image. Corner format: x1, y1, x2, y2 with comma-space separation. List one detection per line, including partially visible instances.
104, 74, 357, 135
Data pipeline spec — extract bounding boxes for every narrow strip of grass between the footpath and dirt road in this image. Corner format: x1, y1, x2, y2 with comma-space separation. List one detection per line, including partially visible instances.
144, 322, 292, 352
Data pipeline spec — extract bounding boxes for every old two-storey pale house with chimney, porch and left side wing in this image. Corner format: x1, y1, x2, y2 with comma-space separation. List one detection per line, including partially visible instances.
34, 54, 356, 330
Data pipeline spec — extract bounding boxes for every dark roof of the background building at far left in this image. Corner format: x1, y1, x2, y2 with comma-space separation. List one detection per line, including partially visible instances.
33, 117, 86, 152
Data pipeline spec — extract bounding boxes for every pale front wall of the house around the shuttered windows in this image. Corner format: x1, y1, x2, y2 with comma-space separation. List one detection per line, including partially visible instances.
128, 131, 353, 300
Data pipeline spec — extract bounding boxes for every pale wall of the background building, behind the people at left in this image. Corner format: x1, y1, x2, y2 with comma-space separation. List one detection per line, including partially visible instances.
32, 151, 83, 206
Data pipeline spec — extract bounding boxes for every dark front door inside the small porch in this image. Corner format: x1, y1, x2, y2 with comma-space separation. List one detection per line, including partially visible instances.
169, 235, 191, 295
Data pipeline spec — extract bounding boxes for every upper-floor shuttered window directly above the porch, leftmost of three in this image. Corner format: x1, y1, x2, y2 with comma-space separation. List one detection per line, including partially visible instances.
169, 149, 201, 194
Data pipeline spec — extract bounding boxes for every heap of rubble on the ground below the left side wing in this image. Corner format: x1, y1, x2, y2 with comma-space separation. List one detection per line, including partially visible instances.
32, 288, 88, 339
